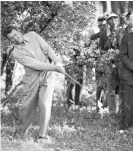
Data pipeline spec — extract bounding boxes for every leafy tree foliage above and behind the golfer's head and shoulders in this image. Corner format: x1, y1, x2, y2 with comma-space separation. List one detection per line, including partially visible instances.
1, 1, 97, 96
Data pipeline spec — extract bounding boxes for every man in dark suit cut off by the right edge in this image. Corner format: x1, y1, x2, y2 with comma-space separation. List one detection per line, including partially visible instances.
119, 12, 133, 129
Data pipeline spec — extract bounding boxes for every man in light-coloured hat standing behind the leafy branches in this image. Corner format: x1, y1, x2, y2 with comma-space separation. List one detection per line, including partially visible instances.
101, 13, 124, 114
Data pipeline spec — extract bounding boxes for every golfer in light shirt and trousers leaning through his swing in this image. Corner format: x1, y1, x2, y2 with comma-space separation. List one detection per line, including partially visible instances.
4, 26, 65, 141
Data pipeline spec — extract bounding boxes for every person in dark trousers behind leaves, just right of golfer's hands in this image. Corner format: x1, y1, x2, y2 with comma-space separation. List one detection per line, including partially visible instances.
67, 47, 83, 107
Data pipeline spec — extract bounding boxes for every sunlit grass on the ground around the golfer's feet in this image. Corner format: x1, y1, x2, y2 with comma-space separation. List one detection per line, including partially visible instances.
1, 98, 133, 151
